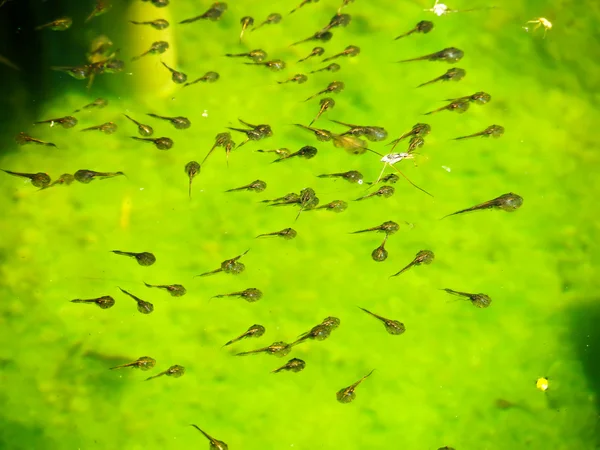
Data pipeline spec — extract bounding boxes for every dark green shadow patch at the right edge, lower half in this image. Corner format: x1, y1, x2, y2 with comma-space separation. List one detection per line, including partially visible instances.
569, 299, 600, 448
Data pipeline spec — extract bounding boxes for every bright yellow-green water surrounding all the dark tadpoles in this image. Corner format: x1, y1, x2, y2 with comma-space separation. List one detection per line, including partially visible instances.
0, 0, 600, 450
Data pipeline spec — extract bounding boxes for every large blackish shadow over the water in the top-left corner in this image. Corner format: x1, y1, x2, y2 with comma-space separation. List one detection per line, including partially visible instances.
0, 0, 112, 142
